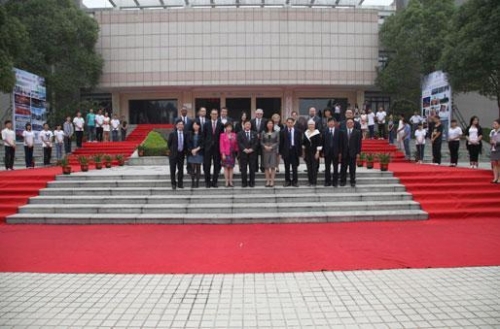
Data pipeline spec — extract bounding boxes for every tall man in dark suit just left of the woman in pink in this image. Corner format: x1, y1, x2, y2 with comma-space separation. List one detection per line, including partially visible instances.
203, 109, 224, 188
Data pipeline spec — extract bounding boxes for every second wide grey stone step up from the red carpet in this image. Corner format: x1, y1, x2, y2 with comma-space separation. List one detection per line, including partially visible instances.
19, 200, 420, 214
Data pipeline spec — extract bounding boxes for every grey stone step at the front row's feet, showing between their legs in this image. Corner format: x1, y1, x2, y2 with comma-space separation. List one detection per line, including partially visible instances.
48, 176, 399, 188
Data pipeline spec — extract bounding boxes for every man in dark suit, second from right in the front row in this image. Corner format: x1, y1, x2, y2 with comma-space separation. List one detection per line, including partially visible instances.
323, 117, 342, 187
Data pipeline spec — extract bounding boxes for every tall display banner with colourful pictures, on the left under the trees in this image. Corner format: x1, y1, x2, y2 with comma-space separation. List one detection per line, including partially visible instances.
12, 68, 47, 143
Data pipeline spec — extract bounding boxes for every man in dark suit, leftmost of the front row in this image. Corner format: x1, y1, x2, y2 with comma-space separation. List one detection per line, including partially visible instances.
168, 119, 187, 190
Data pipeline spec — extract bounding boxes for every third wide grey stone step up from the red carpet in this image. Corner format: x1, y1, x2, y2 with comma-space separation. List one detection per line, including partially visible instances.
29, 189, 412, 205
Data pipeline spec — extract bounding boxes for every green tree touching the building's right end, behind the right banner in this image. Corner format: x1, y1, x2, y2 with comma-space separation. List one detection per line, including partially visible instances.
376, 0, 455, 113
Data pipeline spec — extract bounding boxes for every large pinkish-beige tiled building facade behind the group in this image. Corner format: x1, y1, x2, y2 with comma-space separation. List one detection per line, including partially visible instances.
93, 7, 378, 123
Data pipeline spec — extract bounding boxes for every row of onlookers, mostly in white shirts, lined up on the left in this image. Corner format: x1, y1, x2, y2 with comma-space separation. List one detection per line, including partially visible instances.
2, 109, 128, 170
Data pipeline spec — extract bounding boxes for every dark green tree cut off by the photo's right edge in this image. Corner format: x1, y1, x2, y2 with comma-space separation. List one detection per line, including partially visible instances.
441, 0, 500, 116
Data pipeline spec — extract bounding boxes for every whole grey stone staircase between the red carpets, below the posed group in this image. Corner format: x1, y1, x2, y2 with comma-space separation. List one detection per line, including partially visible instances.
7, 166, 427, 224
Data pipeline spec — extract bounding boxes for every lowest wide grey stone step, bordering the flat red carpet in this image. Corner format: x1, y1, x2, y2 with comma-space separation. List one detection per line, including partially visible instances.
7, 209, 427, 224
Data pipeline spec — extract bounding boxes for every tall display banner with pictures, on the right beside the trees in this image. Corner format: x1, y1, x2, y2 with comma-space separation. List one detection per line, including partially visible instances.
422, 71, 452, 140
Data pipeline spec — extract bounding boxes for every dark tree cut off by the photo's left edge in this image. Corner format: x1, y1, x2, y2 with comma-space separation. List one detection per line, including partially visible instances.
0, 5, 28, 93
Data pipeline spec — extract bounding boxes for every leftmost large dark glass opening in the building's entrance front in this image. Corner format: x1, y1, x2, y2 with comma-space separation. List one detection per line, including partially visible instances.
128, 99, 177, 124
